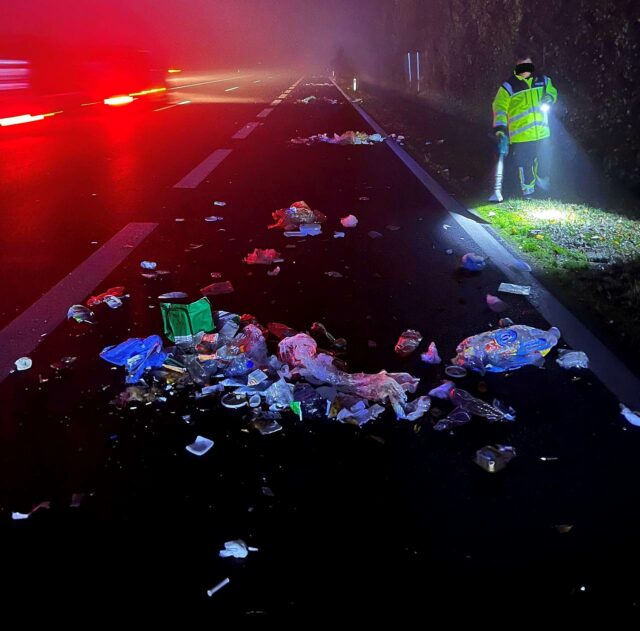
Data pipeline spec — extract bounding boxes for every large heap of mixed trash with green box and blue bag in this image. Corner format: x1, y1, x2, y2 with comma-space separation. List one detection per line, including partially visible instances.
100, 306, 431, 434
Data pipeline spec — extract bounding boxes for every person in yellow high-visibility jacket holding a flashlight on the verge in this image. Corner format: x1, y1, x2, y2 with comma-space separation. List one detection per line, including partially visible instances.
493, 55, 558, 196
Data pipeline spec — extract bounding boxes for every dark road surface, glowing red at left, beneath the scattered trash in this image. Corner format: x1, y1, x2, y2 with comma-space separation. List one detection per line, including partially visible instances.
0, 66, 640, 622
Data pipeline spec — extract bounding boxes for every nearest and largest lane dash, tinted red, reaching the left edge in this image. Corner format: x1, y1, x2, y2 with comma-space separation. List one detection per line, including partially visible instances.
0, 223, 158, 382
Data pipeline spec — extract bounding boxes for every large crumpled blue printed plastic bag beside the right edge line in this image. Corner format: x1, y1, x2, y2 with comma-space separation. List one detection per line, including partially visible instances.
447, 324, 560, 374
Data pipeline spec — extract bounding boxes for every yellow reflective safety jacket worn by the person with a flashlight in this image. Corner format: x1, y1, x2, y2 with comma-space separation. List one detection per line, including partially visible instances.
493, 73, 558, 143
